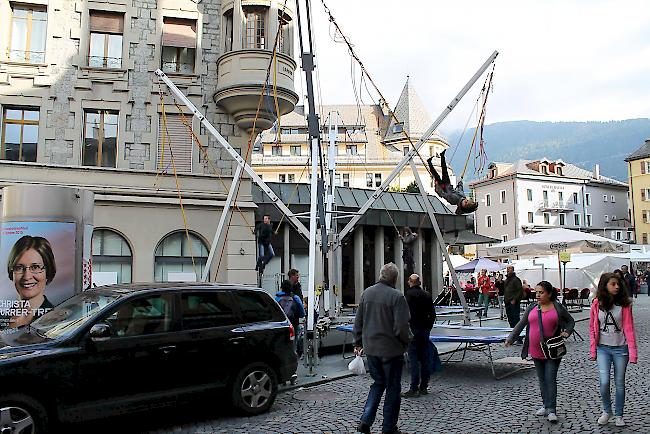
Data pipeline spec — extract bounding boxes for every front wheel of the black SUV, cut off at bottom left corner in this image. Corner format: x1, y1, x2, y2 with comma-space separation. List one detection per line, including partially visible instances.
0, 394, 48, 434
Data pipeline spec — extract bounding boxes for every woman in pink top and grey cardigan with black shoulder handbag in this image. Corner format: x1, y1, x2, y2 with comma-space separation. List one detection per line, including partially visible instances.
506, 280, 574, 423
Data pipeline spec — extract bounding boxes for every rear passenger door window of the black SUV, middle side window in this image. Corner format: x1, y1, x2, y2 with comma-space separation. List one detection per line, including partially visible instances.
181, 291, 238, 330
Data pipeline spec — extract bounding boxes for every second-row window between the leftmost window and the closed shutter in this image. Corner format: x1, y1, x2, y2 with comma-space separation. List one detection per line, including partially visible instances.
82, 110, 119, 167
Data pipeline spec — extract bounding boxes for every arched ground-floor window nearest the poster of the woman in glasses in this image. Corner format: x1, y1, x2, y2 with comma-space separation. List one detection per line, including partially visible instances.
92, 229, 133, 283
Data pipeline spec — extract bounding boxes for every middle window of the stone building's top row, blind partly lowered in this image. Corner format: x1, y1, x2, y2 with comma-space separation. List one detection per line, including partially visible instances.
88, 11, 124, 68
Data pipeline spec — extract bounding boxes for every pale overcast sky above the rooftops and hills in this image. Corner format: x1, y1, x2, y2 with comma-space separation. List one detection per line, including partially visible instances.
296, 0, 650, 132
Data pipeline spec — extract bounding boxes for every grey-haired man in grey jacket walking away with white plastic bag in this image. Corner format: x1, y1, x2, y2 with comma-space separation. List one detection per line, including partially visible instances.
353, 262, 411, 434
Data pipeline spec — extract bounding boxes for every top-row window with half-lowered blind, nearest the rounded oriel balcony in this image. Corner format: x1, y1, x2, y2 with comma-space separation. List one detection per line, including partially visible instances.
162, 17, 196, 74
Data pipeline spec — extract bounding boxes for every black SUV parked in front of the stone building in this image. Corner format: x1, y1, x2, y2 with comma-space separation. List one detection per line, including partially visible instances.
0, 284, 298, 433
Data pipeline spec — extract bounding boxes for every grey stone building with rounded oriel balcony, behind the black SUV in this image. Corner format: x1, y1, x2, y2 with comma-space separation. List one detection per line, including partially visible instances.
0, 0, 298, 283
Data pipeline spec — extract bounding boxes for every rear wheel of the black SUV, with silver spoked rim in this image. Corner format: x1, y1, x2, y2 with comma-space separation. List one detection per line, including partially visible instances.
232, 363, 278, 415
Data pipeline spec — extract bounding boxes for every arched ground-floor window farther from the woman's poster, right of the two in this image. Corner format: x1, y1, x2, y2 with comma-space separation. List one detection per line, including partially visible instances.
154, 231, 208, 282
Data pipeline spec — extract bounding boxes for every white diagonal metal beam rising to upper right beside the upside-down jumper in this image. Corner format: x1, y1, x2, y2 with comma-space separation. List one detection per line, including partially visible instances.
339, 51, 499, 242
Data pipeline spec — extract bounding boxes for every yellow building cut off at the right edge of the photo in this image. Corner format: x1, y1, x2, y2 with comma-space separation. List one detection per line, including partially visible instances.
625, 139, 650, 244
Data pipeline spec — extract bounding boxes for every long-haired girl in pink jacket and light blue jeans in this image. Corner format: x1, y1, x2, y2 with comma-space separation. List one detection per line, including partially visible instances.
589, 273, 637, 426
